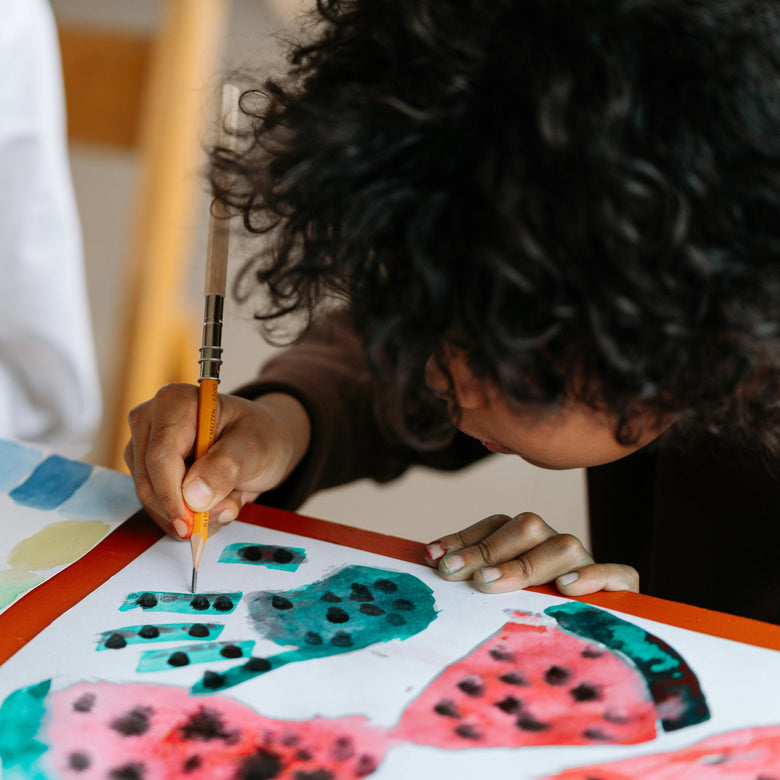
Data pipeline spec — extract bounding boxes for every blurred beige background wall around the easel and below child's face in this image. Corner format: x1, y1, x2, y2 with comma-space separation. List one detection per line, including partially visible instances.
51, 0, 586, 541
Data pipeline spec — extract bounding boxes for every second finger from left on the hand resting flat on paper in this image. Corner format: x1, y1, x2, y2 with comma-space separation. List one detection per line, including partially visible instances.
439, 512, 556, 587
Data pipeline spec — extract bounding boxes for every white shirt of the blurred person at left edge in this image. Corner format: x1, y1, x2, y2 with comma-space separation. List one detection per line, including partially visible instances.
0, 0, 101, 450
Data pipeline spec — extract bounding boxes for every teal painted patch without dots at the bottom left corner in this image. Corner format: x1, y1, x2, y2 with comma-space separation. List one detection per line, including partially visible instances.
0, 680, 51, 780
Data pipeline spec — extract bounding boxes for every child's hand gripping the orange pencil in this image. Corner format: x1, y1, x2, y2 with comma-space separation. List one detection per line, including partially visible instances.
124, 384, 309, 539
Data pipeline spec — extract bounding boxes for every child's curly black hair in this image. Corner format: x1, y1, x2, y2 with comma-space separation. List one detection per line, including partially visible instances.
211, 0, 780, 453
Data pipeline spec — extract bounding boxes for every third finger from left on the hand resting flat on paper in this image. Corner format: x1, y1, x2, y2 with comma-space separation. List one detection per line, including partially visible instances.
473, 534, 593, 593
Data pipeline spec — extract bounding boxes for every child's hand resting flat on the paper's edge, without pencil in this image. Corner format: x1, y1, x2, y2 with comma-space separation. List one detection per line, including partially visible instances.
425, 512, 639, 596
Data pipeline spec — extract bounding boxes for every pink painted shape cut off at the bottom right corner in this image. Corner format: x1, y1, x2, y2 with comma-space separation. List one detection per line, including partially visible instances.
544, 726, 780, 780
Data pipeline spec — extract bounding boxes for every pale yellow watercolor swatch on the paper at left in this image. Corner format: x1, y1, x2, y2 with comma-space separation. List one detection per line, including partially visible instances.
8, 520, 111, 571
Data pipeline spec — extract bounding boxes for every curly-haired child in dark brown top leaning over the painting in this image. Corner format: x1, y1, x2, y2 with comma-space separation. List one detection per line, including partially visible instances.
126, 0, 780, 620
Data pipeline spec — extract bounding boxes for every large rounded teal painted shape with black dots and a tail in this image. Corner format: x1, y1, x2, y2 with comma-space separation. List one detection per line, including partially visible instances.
193, 566, 436, 693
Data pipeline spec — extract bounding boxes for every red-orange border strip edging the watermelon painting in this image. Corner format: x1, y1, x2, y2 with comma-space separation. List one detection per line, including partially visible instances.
0, 504, 780, 664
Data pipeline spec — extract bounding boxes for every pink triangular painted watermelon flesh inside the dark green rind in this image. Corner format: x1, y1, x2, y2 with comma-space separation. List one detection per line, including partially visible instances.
391, 615, 657, 749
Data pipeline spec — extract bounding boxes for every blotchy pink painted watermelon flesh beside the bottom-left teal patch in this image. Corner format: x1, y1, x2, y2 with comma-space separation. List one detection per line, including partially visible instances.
47, 683, 388, 780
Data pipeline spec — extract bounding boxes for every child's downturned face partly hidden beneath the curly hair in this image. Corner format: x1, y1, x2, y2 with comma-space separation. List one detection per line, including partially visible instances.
425, 351, 673, 469
